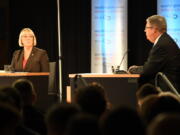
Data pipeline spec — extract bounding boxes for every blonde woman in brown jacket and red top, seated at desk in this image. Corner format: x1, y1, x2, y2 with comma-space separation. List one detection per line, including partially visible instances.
11, 28, 49, 72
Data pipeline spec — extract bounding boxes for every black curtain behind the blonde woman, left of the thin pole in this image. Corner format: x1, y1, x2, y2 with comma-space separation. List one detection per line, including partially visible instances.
9, 0, 58, 61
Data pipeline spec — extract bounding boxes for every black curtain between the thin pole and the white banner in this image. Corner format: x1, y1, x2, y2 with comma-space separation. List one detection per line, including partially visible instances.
60, 0, 91, 100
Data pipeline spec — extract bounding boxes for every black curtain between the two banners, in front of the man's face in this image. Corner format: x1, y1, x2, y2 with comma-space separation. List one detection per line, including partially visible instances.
128, 0, 157, 66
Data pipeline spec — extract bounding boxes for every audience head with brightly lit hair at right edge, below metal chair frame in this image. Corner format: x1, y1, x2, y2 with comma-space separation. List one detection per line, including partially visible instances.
140, 92, 180, 124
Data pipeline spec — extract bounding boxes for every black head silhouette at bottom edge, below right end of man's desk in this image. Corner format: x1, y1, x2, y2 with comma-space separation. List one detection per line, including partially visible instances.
101, 106, 145, 135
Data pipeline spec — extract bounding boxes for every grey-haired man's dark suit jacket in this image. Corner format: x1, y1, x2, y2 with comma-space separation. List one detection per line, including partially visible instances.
139, 33, 180, 92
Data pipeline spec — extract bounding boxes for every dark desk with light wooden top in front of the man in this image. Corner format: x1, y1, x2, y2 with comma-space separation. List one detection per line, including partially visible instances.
69, 73, 139, 108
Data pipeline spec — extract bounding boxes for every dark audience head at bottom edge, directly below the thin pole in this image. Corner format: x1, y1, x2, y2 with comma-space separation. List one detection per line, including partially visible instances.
46, 103, 80, 135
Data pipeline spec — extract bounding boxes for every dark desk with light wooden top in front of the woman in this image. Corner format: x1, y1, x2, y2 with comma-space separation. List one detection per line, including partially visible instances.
0, 71, 51, 112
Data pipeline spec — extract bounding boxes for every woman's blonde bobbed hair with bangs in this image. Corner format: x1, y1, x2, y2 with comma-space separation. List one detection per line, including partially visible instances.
18, 28, 37, 47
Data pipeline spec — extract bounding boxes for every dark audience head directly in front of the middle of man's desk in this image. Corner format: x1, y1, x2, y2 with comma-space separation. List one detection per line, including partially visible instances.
74, 83, 108, 117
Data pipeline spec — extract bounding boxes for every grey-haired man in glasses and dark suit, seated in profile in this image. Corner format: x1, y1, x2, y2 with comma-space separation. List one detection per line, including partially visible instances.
128, 15, 180, 91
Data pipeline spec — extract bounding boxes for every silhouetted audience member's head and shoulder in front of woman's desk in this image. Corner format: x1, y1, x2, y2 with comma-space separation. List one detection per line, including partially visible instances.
13, 79, 47, 135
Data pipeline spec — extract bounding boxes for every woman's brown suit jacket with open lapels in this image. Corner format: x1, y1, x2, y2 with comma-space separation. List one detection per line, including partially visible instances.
11, 47, 49, 72
